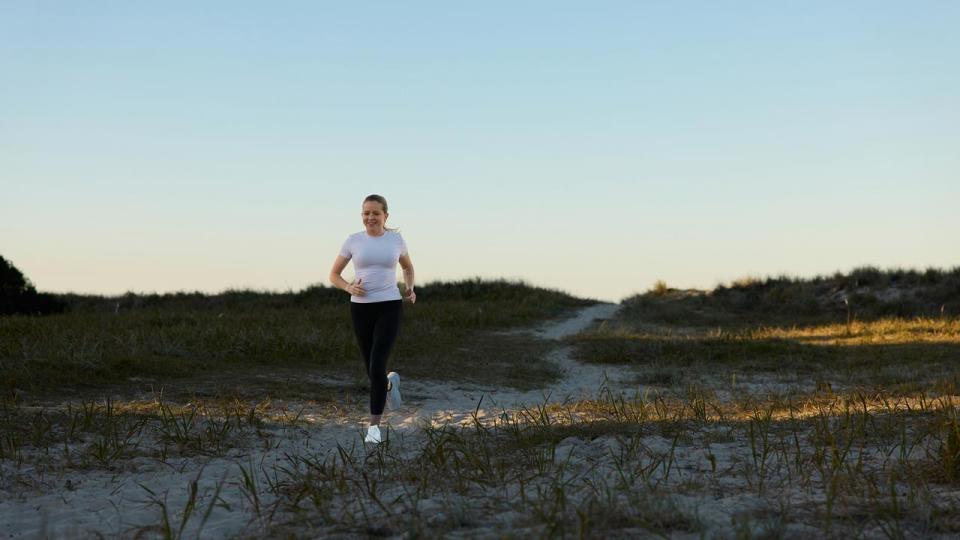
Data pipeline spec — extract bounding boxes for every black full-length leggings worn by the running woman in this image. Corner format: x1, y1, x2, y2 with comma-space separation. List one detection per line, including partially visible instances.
350, 300, 403, 414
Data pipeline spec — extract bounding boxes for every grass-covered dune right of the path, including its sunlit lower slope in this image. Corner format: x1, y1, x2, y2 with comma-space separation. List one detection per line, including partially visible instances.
574, 268, 960, 391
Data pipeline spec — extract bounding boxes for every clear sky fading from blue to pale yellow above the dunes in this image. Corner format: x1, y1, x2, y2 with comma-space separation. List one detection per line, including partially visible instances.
0, 0, 960, 300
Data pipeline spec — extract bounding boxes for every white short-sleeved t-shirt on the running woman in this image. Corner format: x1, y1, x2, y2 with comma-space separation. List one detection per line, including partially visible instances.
340, 231, 407, 304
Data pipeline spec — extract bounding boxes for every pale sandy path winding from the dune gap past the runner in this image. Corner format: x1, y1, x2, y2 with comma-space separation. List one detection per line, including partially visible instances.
0, 304, 618, 538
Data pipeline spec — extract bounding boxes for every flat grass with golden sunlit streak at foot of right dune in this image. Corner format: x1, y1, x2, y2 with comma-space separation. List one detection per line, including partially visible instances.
571, 318, 960, 392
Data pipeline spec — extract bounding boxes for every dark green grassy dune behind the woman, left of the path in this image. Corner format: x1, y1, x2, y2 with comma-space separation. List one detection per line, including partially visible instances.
0, 279, 590, 396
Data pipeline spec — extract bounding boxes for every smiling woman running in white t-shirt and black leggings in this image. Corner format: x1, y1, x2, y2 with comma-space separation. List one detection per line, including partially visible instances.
330, 195, 417, 443
